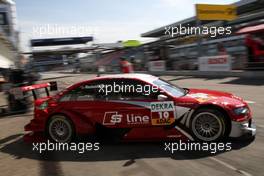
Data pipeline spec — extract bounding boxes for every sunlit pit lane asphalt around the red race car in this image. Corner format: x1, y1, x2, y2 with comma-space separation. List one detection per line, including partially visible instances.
0, 74, 264, 176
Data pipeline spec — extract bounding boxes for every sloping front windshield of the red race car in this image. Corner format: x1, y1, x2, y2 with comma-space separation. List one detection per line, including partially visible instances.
153, 79, 187, 97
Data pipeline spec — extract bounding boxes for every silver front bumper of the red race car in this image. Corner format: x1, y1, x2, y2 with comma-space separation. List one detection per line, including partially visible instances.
229, 119, 257, 137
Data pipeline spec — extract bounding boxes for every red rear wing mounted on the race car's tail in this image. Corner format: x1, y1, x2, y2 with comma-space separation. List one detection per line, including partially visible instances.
9, 81, 58, 100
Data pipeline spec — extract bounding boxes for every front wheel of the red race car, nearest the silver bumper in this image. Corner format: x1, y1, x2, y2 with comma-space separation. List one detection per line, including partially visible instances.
190, 108, 228, 142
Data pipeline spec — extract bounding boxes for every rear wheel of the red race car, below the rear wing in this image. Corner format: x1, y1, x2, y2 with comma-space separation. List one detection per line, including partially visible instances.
47, 115, 75, 143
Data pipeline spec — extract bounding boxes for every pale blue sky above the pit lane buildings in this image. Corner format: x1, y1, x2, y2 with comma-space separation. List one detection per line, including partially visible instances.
15, 0, 236, 50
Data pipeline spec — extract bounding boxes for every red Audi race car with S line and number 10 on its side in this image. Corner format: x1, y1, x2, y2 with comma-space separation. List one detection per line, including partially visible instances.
25, 74, 256, 142
